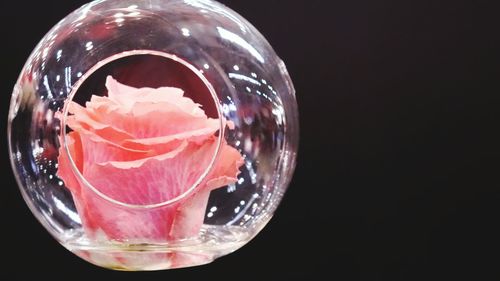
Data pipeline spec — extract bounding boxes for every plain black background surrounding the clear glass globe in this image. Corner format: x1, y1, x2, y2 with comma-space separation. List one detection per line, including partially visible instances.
0, 0, 500, 280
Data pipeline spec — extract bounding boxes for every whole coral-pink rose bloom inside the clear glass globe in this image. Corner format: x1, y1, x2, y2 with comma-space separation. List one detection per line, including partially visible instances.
58, 77, 243, 243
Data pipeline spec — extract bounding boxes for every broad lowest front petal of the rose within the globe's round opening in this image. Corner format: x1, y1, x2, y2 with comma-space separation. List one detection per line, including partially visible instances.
84, 141, 216, 205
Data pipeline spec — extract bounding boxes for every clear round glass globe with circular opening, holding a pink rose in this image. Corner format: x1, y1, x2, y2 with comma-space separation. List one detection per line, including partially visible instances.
8, 0, 298, 270
